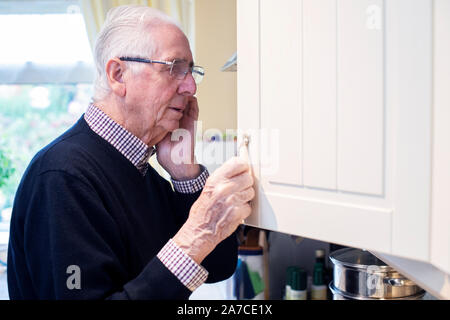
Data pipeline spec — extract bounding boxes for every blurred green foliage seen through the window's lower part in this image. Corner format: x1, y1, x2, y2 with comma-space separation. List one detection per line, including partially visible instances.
0, 84, 92, 215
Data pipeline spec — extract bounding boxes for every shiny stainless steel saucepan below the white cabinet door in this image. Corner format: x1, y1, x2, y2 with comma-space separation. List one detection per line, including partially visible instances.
330, 248, 425, 299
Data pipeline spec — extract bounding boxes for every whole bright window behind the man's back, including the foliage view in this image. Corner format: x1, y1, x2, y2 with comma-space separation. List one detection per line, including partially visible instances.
0, 0, 94, 280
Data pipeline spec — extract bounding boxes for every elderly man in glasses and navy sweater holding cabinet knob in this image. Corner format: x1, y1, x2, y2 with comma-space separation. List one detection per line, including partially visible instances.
8, 6, 254, 299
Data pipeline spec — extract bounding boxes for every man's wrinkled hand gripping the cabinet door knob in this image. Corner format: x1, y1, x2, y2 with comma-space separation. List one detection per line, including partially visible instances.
173, 157, 255, 263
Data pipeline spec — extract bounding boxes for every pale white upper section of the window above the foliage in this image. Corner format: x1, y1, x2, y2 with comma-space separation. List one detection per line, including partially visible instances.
0, 1, 94, 84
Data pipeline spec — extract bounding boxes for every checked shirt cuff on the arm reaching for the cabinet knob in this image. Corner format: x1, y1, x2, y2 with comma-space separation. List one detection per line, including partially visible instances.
157, 239, 208, 291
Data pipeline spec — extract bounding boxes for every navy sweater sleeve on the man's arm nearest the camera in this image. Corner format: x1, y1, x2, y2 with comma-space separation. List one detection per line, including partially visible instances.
12, 171, 191, 299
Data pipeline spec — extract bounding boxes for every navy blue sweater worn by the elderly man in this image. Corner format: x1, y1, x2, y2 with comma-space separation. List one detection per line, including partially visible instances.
7, 117, 237, 299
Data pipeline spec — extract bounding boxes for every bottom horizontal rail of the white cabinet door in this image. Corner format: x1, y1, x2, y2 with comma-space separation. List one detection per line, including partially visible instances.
259, 192, 392, 252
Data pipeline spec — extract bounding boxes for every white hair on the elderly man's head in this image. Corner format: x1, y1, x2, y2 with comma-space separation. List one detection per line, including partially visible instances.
93, 5, 181, 101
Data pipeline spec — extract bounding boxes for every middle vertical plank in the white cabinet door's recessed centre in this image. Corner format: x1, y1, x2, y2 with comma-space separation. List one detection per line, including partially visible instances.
303, 0, 337, 190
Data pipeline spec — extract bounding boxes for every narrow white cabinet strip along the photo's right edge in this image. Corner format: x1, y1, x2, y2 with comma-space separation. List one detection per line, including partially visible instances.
430, 0, 450, 276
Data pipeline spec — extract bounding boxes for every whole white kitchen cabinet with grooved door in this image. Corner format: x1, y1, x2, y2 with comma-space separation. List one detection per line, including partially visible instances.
237, 0, 450, 282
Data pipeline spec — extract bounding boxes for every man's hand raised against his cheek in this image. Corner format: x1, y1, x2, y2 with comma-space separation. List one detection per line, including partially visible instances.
156, 97, 200, 180
